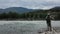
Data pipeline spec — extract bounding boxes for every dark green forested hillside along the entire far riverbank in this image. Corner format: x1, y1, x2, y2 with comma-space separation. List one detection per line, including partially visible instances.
0, 7, 60, 20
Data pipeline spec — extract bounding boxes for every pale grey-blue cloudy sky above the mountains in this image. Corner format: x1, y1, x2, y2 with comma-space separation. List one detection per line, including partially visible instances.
0, 0, 60, 9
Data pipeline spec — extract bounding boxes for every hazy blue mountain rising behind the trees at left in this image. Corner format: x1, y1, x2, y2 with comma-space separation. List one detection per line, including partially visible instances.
0, 7, 33, 13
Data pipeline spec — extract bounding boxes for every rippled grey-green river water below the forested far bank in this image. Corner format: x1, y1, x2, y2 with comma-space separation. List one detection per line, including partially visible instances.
0, 21, 60, 34
